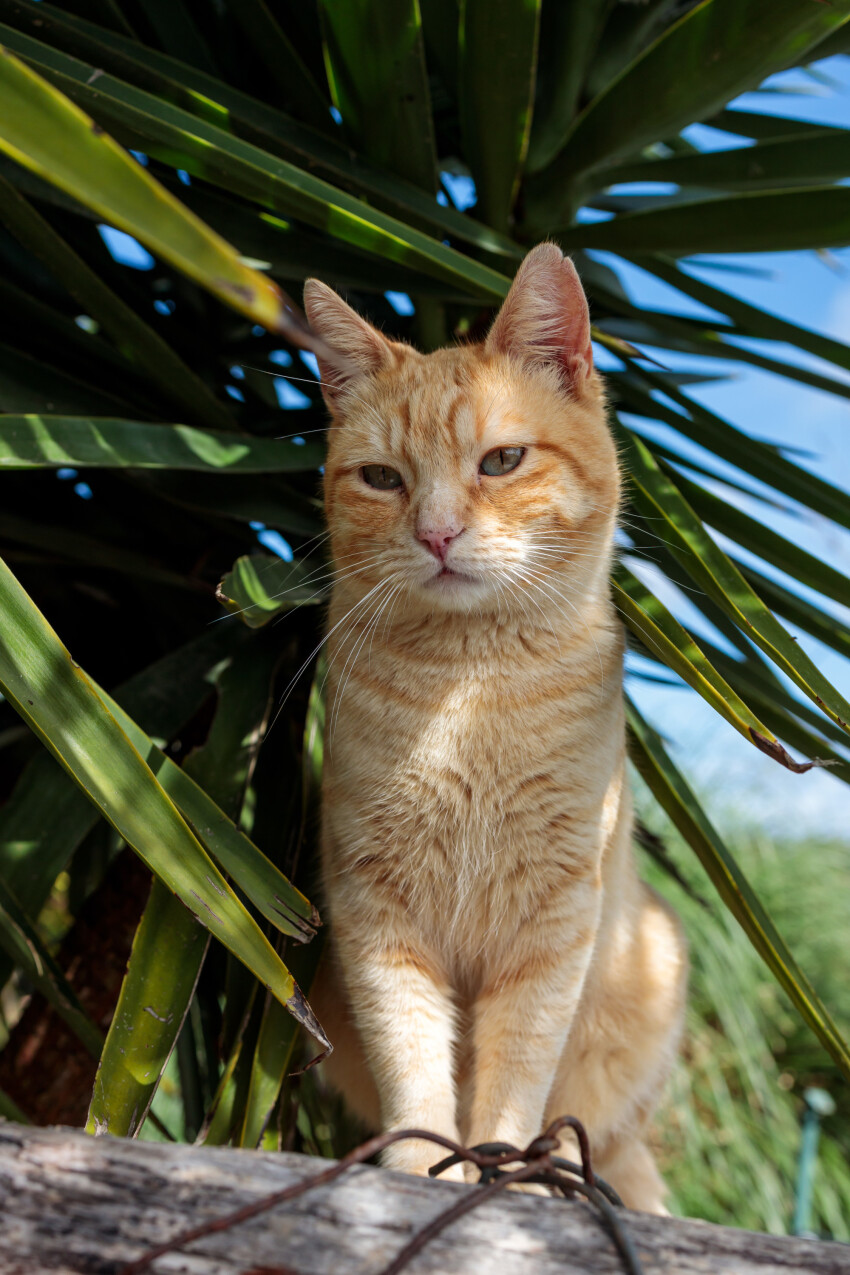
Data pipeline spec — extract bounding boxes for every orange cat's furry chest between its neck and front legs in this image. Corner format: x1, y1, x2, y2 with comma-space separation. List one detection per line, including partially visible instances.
324, 622, 623, 958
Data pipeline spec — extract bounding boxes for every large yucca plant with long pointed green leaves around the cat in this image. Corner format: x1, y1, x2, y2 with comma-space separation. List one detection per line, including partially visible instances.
0, 0, 850, 1178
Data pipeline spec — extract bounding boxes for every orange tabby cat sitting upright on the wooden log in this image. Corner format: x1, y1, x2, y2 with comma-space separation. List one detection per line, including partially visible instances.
305, 244, 687, 1213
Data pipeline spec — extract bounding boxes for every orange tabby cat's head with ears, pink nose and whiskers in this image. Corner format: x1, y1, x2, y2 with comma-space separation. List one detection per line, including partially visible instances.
305, 244, 619, 622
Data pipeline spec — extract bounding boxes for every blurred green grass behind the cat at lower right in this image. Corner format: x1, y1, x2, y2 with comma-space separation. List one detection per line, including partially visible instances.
645, 795, 850, 1239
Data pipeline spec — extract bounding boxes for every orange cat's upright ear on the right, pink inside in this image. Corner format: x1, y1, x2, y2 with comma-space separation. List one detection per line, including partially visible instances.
484, 244, 593, 395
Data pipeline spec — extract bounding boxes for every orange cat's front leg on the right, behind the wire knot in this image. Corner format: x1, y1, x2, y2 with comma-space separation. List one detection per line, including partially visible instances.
468, 898, 598, 1148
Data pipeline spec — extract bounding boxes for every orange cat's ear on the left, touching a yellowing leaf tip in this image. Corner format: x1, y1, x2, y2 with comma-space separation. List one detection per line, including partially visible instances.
305, 279, 391, 411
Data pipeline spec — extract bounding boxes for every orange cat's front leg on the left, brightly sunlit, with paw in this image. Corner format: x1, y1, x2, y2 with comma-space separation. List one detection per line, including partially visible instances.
338, 935, 463, 1181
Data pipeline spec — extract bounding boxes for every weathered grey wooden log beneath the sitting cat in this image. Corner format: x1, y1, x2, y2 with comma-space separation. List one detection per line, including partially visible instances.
0, 1121, 850, 1275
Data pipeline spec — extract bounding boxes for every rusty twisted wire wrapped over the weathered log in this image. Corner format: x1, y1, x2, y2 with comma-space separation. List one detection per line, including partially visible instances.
120, 1116, 644, 1275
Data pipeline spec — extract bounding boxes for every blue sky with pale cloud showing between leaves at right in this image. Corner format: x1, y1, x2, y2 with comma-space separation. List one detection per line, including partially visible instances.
619, 57, 850, 838
